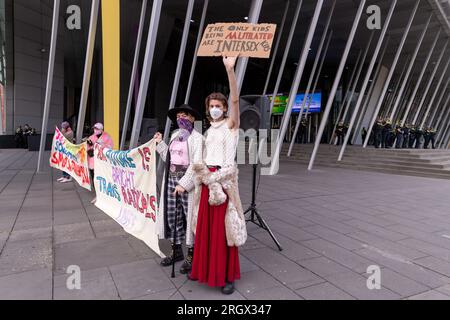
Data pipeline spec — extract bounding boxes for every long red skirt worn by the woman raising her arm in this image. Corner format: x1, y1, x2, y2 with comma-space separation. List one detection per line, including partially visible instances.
191, 185, 241, 287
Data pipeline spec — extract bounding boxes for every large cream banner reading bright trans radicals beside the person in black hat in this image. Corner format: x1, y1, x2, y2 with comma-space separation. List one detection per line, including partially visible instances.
94, 140, 164, 257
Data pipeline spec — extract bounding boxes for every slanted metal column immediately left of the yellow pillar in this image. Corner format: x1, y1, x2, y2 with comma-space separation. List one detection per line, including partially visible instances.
76, 0, 100, 143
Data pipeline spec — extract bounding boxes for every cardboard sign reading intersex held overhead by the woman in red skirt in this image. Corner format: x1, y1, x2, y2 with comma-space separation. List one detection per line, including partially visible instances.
197, 22, 277, 58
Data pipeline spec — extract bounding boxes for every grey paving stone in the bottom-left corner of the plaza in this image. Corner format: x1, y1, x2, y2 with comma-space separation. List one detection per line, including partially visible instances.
0, 268, 52, 300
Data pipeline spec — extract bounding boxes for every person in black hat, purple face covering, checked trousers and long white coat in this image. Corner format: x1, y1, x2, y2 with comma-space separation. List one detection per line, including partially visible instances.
153, 104, 204, 274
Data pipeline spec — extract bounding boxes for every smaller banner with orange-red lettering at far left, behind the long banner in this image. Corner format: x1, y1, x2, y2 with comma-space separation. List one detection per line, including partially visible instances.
50, 128, 91, 190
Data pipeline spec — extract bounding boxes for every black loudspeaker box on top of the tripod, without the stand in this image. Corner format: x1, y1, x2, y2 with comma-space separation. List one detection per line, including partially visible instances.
239, 95, 270, 131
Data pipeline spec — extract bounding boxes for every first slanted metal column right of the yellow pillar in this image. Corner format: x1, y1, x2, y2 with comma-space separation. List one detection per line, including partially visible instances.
120, 0, 147, 150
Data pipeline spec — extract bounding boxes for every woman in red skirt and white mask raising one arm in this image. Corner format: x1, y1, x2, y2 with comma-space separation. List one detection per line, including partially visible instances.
189, 57, 247, 294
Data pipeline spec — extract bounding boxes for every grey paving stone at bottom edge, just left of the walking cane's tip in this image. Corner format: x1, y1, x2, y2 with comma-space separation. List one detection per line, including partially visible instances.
109, 260, 175, 299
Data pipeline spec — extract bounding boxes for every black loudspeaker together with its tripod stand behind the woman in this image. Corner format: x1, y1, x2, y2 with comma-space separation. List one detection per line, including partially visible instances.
239, 95, 283, 251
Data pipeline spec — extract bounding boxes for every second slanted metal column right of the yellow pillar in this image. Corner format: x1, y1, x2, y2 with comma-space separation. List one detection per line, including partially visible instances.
130, 0, 163, 149
